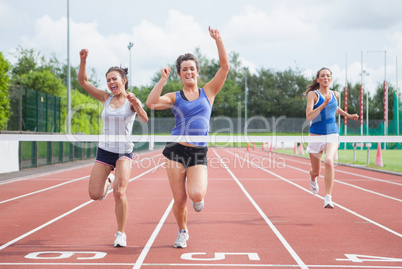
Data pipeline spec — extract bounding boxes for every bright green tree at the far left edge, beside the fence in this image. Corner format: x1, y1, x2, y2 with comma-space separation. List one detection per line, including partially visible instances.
0, 52, 11, 129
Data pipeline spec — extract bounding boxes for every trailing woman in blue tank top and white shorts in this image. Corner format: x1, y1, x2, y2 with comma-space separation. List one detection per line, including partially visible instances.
305, 68, 359, 208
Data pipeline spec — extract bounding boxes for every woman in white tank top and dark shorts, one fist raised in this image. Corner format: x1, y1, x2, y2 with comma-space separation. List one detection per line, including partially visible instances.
78, 49, 148, 247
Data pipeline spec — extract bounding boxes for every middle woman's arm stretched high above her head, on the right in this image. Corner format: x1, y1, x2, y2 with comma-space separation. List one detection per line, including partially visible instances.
204, 27, 230, 99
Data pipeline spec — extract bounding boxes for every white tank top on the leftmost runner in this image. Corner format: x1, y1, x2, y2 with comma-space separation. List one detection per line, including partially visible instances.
99, 95, 137, 154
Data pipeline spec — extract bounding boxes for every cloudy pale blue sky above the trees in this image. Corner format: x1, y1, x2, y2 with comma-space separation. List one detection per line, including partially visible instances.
0, 0, 402, 95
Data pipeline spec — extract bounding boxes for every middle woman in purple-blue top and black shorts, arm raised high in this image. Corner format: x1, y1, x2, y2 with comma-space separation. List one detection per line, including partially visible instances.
146, 27, 229, 248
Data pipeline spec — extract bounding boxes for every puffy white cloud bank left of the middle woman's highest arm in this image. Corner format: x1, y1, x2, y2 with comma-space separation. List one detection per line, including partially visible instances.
13, 10, 217, 88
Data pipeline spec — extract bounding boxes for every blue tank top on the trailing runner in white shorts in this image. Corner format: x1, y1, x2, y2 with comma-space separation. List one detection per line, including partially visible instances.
310, 90, 339, 135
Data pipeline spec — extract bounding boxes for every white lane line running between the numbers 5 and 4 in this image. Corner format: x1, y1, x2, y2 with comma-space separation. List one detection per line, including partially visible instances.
212, 149, 308, 269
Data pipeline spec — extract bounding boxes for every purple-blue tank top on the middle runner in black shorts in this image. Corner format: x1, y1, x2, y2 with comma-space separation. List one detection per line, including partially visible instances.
172, 88, 212, 147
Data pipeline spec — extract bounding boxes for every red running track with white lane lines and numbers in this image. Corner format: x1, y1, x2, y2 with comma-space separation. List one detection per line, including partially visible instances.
0, 148, 402, 269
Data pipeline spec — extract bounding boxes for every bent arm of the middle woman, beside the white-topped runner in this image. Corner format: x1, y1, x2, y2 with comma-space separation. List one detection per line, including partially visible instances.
145, 66, 176, 110
